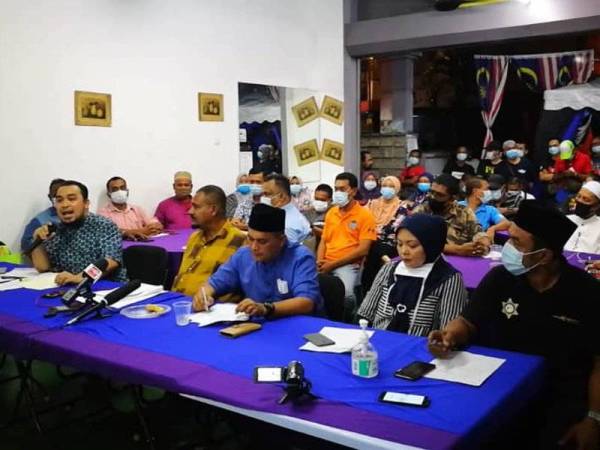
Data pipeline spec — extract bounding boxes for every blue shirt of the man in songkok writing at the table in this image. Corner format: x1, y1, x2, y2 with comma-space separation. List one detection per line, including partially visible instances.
208, 242, 322, 313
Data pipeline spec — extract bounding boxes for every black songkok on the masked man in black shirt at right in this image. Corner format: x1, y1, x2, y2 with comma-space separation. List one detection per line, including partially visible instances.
514, 200, 577, 252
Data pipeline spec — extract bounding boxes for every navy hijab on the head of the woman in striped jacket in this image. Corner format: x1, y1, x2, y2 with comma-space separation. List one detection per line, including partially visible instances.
399, 214, 448, 263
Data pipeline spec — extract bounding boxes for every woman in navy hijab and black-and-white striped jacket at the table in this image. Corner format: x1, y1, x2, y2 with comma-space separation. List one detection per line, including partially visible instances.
358, 214, 467, 336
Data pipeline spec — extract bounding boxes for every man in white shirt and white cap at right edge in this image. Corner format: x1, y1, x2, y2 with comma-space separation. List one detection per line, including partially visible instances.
565, 181, 600, 253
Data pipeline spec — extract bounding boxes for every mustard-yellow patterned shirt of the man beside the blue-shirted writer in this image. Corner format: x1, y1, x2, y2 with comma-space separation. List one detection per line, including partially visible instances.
173, 222, 246, 296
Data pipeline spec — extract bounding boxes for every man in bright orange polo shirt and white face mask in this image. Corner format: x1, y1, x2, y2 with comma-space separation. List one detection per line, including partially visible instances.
317, 172, 377, 321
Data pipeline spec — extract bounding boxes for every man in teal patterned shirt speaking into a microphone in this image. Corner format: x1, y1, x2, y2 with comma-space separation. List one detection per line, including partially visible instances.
31, 180, 127, 285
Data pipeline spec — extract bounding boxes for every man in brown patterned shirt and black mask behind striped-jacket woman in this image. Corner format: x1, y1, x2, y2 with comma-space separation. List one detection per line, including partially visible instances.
413, 173, 492, 256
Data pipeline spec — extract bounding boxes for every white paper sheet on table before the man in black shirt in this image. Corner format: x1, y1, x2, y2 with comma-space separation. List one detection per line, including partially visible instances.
425, 352, 505, 386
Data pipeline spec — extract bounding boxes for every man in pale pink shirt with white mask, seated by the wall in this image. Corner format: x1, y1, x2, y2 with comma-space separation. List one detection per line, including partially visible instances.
98, 177, 163, 241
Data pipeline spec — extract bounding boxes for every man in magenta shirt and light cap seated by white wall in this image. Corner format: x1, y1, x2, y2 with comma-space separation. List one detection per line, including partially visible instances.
154, 171, 193, 230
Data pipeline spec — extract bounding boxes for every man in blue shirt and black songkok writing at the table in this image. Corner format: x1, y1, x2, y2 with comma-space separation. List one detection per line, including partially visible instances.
194, 204, 322, 318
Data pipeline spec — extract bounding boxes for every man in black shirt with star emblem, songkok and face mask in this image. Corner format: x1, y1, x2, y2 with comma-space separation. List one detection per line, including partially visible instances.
429, 200, 600, 449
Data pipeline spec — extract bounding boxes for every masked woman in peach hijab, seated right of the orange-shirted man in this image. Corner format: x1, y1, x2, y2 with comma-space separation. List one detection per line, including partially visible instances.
361, 176, 408, 293
